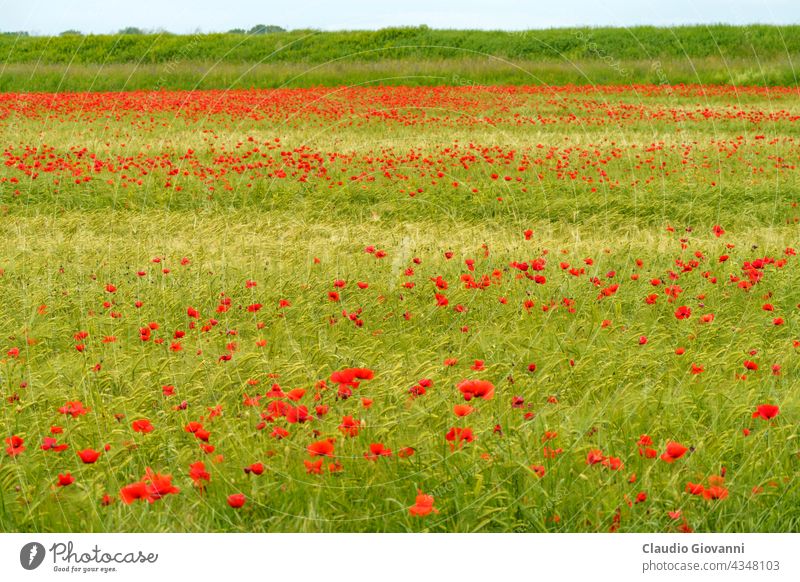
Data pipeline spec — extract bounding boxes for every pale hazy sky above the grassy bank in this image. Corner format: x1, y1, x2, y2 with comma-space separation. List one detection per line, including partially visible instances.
0, 0, 800, 35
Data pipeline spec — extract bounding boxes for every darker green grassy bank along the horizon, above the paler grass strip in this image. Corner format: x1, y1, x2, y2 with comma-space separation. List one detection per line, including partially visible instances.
0, 25, 800, 64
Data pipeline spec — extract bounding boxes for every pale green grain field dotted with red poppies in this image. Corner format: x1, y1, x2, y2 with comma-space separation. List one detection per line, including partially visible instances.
0, 82, 800, 532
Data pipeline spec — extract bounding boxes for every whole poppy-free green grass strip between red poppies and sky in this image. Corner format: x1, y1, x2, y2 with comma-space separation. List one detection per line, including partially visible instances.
0, 25, 800, 92
